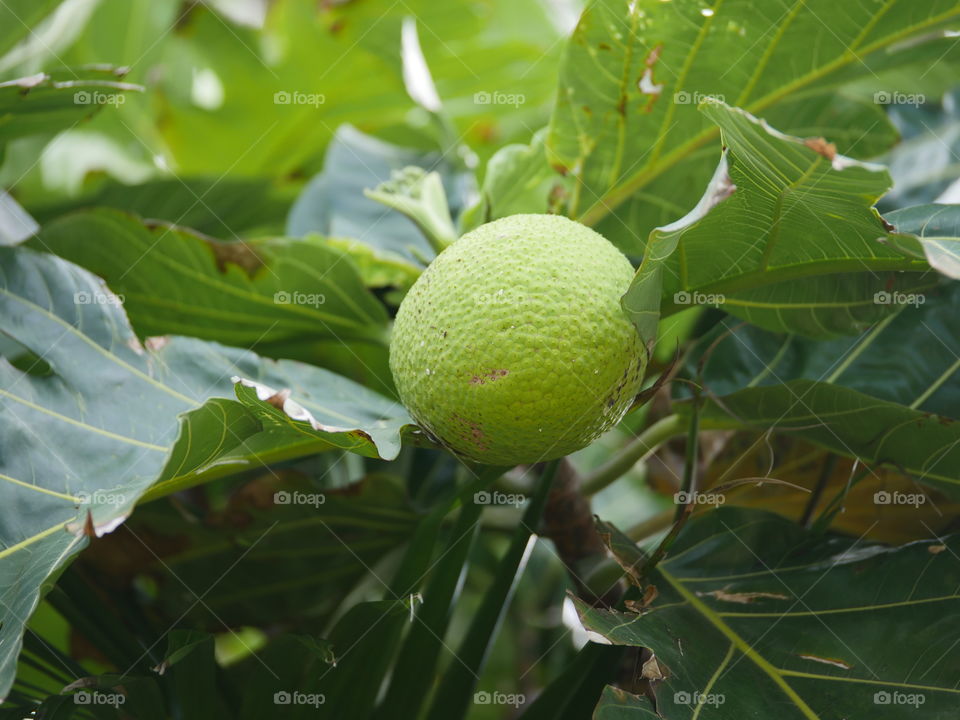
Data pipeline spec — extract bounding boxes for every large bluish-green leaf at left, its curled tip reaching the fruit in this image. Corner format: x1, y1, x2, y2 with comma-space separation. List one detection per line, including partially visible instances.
0, 247, 408, 694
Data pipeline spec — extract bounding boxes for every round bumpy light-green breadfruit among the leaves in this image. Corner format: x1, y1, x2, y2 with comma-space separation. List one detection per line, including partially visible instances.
390, 215, 644, 465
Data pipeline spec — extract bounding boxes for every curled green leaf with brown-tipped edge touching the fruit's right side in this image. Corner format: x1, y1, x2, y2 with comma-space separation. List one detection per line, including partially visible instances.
623, 101, 929, 343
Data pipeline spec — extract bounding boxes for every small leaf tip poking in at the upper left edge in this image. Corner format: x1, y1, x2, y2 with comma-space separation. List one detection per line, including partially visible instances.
0, 68, 143, 150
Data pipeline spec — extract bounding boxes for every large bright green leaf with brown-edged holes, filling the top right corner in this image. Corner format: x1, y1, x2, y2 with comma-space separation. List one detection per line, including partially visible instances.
548, 0, 960, 243
